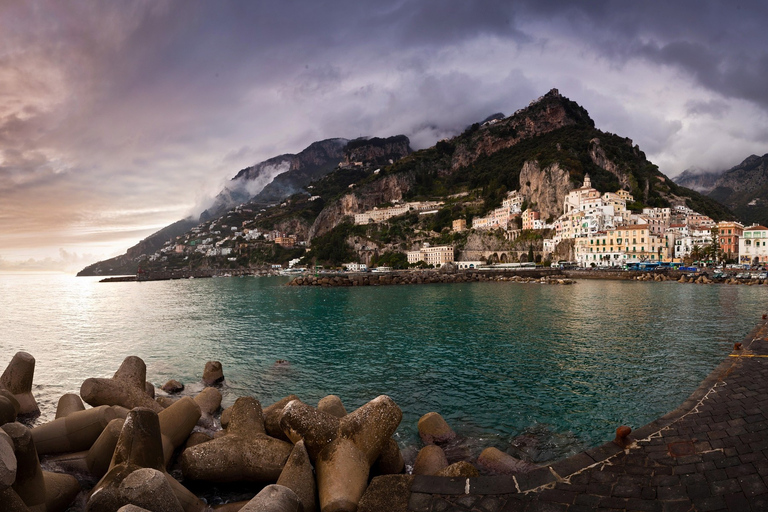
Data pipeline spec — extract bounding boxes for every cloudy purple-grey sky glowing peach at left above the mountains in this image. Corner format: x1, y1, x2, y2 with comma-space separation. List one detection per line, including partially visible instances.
0, 0, 768, 271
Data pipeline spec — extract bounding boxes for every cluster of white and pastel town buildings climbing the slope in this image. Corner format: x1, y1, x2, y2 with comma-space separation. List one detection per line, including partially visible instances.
408, 175, 768, 268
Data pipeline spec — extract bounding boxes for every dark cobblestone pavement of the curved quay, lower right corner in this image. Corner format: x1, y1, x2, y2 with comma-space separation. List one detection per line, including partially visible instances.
408, 321, 768, 512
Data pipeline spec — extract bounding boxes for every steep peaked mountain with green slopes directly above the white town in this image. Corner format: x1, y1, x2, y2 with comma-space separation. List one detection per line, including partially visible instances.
310, 89, 733, 243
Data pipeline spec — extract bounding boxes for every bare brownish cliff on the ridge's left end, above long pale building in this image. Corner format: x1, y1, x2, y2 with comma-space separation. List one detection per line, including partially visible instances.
309, 174, 413, 240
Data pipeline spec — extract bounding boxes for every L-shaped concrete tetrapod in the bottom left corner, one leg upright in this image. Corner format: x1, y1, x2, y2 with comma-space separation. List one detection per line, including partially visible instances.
2, 423, 80, 512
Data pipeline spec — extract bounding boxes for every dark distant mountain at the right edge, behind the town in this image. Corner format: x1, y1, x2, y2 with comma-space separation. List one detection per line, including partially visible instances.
675, 154, 768, 225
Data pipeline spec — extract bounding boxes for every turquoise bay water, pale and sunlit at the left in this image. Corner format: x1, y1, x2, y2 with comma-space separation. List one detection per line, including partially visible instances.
0, 275, 768, 462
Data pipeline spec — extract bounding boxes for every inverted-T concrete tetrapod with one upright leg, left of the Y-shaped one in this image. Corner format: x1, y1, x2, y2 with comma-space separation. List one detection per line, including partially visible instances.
181, 397, 293, 482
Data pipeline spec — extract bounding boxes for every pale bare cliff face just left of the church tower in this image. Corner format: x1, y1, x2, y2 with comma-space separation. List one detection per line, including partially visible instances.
520, 161, 574, 220
